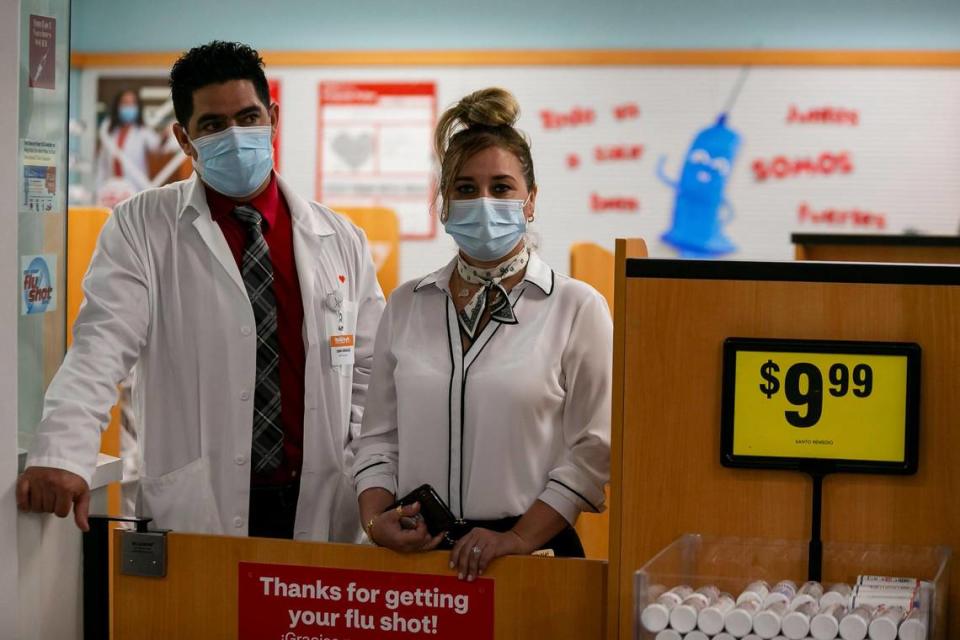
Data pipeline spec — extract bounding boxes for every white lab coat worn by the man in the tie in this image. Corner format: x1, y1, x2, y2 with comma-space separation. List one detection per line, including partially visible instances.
27, 176, 384, 542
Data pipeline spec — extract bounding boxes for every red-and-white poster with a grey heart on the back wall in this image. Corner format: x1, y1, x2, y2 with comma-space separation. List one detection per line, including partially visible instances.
317, 82, 437, 240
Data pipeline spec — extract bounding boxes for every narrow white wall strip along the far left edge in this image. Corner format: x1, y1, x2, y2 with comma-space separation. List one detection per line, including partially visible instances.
0, 0, 20, 635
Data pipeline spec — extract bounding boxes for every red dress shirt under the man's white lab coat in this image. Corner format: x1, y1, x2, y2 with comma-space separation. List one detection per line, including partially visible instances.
204, 174, 306, 486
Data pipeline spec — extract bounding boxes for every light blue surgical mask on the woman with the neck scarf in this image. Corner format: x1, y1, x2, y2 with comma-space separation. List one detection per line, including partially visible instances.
443, 197, 527, 262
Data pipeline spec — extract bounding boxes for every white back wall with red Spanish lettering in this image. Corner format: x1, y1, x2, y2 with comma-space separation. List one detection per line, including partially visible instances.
80, 66, 960, 281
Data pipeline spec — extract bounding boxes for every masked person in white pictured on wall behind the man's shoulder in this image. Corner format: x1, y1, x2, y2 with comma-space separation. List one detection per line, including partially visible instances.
96, 89, 162, 195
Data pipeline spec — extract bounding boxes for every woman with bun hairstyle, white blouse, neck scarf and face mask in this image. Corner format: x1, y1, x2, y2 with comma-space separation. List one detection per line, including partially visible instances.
354, 88, 613, 580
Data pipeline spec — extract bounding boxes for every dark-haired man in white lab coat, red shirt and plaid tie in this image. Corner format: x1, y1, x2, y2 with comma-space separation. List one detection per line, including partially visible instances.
17, 42, 384, 541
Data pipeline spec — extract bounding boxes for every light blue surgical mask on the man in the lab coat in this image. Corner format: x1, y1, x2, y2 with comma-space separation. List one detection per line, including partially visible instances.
191, 125, 273, 198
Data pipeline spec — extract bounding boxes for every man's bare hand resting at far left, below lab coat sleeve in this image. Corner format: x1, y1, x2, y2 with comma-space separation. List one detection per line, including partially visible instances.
17, 467, 90, 531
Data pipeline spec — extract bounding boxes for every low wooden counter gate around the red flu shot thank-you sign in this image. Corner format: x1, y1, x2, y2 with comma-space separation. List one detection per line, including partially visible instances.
111, 531, 606, 640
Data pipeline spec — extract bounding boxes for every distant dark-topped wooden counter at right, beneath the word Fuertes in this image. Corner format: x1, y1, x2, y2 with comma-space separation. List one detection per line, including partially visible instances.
790, 233, 960, 264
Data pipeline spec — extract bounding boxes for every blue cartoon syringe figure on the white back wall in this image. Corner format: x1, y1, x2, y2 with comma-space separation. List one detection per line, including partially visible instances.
657, 113, 740, 257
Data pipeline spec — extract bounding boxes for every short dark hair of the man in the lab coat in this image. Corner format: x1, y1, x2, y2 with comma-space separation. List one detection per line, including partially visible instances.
170, 40, 270, 127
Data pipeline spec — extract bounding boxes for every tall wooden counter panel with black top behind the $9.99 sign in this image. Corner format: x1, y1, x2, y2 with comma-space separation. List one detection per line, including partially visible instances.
607, 241, 960, 640
